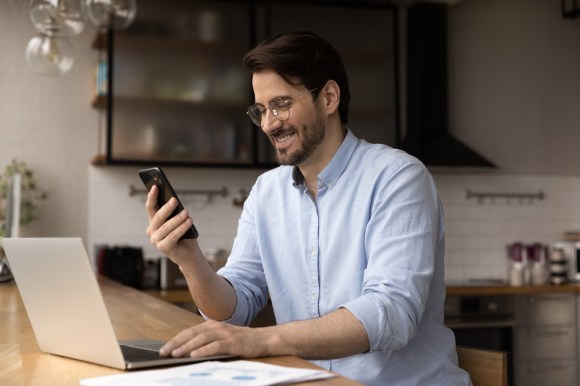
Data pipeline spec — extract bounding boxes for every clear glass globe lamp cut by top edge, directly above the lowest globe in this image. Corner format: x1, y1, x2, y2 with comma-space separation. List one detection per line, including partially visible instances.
28, 0, 86, 37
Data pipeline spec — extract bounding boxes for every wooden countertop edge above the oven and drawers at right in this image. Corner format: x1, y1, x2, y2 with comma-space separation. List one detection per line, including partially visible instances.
447, 283, 580, 296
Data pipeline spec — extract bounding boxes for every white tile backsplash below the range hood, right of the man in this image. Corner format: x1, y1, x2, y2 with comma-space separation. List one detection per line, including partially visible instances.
434, 172, 580, 280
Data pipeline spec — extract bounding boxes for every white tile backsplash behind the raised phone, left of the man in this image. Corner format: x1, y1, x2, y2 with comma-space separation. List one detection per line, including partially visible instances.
89, 166, 260, 258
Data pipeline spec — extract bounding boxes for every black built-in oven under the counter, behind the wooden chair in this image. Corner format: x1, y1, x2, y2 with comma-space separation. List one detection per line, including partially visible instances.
445, 295, 515, 385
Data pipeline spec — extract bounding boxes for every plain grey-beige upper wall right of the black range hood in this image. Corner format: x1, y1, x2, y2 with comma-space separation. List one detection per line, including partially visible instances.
449, 0, 580, 175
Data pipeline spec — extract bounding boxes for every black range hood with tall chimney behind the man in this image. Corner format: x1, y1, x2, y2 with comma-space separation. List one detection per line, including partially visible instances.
400, 3, 496, 169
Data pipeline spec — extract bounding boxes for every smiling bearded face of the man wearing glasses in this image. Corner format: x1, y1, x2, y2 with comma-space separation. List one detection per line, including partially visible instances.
252, 71, 325, 165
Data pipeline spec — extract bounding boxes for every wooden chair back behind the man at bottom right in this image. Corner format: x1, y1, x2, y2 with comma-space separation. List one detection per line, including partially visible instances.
457, 346, 507, 386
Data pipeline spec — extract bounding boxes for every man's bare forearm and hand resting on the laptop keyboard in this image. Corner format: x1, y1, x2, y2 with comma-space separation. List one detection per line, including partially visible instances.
160, 308, 369, 359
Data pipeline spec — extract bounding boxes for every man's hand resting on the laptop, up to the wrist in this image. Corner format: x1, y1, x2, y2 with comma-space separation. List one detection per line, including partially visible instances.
159, 320, 269, 358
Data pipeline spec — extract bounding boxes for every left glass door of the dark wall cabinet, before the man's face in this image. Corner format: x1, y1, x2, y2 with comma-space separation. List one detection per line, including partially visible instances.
108, 0, 256, 165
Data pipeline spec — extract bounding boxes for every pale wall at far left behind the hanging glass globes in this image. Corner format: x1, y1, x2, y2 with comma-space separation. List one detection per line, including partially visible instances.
0, 0, 98, 237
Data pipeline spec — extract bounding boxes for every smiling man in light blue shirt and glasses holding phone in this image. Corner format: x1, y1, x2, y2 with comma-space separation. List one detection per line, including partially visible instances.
146, 32, 470, 386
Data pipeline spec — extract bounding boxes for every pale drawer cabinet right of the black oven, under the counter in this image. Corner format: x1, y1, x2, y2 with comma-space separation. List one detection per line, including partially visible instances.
513, 293, 578, 386
